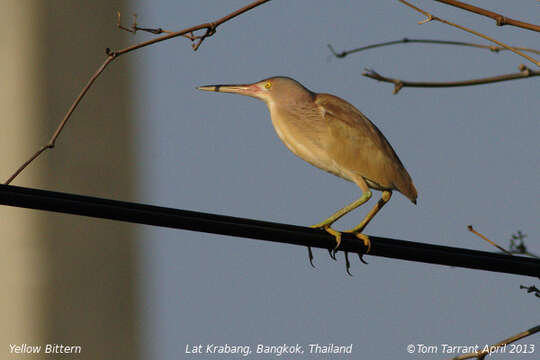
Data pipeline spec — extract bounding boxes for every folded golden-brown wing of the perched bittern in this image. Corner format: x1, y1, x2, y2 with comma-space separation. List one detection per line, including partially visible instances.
315, 94, 417, 201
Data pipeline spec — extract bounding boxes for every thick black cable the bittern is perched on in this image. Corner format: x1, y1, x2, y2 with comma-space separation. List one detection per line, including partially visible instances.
0, 185, 540, 277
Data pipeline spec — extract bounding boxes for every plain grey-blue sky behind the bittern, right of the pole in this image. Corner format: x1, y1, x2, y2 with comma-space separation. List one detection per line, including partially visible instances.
128, 0, 540, 359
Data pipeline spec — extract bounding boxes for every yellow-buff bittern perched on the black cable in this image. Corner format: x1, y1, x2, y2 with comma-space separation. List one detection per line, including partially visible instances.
197, 76, 418, 275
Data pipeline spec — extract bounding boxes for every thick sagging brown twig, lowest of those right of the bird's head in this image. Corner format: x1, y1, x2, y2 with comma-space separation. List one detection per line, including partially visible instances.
362, 64, 540, 95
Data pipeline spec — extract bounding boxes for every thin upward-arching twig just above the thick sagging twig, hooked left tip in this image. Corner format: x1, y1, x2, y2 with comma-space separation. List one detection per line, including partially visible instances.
328, 38, 540, 58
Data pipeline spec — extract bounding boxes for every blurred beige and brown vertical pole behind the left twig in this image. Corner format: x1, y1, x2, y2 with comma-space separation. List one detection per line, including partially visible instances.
0, 0, 139, 359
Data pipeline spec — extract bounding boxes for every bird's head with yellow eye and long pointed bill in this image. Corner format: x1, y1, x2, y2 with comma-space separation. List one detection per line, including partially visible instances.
197, 76, 315, 107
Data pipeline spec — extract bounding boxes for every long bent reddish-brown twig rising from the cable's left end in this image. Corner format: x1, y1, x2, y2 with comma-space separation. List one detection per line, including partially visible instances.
4, 0, 270, 185
